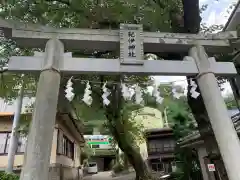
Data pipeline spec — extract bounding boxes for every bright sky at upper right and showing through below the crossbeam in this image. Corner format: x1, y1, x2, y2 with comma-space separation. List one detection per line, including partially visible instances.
154, 0, 238, 96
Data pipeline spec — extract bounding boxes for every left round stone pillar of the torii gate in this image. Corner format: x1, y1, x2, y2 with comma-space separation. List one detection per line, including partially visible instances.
20, 39, 64, 180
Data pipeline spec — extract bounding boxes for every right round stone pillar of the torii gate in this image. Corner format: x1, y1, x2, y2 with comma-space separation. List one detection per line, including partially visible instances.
189, 45, 240, 180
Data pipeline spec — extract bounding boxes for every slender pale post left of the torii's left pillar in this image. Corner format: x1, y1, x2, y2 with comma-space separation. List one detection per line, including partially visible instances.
6, 84, 24, 173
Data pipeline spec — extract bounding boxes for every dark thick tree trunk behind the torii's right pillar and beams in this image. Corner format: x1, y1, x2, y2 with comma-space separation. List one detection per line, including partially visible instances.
182, 0, 228, 178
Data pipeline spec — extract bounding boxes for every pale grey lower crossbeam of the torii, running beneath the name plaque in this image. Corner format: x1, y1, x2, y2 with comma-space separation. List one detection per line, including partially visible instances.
9, 56, 237, 76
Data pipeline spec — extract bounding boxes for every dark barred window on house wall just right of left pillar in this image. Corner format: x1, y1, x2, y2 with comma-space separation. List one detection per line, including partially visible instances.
57, 133, 74, 159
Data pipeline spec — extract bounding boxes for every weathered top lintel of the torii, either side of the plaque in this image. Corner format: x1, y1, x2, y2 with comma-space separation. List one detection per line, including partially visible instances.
0, 18, 237, 53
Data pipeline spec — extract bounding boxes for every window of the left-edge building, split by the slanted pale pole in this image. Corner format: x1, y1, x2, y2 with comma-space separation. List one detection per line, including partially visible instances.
0, 132, 27, 154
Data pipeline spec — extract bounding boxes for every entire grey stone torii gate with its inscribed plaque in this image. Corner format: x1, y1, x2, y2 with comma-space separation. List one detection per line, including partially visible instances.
0, 19, 240, 180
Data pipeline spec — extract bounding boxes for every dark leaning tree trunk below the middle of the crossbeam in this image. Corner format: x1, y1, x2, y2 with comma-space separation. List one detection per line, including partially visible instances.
106, 84, 152, 180
